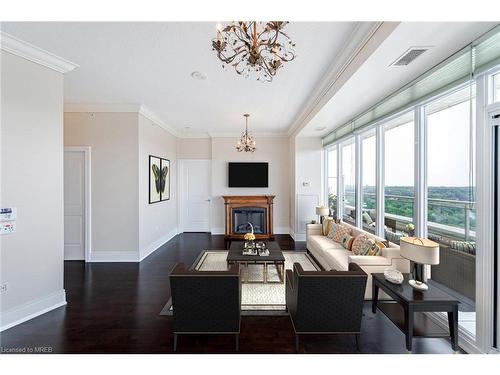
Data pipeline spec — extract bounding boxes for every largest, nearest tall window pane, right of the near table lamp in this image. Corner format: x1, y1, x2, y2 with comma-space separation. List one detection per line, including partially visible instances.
425, 86, 476, 334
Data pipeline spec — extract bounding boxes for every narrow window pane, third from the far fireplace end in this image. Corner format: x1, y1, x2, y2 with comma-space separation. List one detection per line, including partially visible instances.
361, 130, 377, 233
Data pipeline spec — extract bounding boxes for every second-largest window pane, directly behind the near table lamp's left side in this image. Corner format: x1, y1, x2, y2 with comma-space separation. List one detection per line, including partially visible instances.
384, 112, 415, 244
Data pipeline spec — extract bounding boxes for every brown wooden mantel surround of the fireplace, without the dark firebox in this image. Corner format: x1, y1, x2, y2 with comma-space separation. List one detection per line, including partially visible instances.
222, 195, 275, 240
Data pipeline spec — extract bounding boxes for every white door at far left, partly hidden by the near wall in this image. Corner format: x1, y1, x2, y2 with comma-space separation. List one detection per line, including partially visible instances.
64, 150, 85, 260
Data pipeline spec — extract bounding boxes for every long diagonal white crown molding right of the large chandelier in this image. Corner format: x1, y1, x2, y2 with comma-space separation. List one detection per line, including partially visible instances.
287, 22, 399, 137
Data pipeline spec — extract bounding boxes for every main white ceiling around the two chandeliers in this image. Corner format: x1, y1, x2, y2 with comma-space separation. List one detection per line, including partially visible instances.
1, 22, 358, 135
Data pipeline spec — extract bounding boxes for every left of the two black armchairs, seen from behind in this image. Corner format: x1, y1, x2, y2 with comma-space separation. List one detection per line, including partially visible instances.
169, 263, 241, 351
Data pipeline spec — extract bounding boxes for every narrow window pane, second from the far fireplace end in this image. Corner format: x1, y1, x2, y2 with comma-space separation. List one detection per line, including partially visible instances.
341, 138, 356, 225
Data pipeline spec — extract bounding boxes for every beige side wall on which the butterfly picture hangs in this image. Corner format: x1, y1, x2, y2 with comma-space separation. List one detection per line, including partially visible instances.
138, 115, 178, 258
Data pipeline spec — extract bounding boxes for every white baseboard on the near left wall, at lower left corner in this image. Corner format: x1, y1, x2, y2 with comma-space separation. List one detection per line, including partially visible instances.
0, 289, 66, 332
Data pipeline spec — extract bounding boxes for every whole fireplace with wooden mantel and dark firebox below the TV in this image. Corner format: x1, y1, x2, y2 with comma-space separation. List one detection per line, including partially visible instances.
222, 195, 274, 240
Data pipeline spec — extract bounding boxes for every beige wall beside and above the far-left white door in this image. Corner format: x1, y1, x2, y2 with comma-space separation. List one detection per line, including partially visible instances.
64, 113, 139, 260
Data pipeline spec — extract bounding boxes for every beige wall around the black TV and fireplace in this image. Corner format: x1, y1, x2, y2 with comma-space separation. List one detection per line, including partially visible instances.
211, 137, 291, 233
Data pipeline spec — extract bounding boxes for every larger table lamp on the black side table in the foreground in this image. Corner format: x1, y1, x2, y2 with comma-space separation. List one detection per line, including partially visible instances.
400, 237, 439, 290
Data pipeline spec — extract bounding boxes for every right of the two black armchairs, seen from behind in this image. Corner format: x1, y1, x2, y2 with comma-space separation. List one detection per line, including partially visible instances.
286, 263, 368, 350
